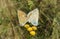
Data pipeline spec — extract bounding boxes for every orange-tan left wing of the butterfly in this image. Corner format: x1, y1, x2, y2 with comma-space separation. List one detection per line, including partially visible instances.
18, 10, 27, 26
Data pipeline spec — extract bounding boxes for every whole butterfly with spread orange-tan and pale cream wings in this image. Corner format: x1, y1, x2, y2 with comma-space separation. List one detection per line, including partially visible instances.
18, 8, 39, 26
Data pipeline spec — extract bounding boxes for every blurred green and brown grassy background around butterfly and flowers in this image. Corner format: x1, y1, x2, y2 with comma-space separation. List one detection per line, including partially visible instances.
0, 0, 60, 39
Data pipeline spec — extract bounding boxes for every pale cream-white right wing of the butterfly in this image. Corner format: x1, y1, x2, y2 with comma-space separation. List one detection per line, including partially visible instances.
27, 8, 39, 26
